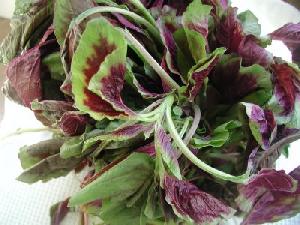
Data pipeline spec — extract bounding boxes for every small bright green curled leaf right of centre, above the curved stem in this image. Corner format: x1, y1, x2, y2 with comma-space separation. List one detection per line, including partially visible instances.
193, 120, 242, 148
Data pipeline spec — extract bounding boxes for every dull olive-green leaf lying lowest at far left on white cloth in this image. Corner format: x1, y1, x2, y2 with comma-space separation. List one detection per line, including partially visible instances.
17, 153, 82, 184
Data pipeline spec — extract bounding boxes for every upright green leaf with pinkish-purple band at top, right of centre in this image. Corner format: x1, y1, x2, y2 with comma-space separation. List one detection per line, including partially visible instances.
182, 0, 212, 62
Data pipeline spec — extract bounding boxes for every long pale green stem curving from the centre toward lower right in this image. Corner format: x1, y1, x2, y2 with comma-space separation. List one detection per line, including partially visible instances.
166, 96, 248, 183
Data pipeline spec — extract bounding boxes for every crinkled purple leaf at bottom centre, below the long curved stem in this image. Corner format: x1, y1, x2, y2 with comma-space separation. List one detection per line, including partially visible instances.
164, 176, 234, 224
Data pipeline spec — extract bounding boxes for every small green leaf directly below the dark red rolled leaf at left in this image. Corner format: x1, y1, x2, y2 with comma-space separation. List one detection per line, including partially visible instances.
60, 136, 83, 159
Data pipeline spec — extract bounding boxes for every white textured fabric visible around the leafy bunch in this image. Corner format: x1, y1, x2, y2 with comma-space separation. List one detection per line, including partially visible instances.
0, 0, 300, 225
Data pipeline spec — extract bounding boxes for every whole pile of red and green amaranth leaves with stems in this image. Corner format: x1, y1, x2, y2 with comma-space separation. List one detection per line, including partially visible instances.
0, 0, 300, 225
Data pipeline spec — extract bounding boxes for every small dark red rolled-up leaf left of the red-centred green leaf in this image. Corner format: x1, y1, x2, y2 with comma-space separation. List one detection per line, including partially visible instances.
59, 112, 88, 136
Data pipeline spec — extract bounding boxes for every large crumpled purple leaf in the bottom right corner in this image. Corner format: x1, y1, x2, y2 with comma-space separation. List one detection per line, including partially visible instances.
237, 167, 300, 225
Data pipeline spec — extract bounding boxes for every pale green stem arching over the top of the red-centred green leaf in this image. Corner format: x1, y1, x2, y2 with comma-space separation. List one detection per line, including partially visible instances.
69, 6, 161, 42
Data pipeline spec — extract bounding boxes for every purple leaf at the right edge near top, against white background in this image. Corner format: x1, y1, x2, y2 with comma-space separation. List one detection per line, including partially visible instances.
269, 23, 300, 63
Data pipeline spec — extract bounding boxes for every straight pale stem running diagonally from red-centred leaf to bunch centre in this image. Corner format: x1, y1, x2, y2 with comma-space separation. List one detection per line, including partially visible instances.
124, 30, 180, 90
